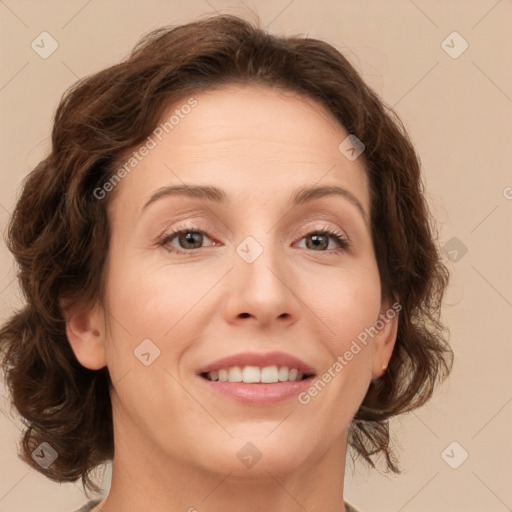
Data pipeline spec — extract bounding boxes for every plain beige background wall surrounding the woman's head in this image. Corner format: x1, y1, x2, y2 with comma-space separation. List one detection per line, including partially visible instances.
0, 0, 512, 512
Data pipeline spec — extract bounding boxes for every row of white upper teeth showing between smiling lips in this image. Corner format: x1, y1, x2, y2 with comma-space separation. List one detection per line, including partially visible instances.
206, 365, 304, 384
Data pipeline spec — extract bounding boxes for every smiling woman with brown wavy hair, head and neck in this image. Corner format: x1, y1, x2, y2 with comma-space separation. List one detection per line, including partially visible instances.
0, 15, 452, 512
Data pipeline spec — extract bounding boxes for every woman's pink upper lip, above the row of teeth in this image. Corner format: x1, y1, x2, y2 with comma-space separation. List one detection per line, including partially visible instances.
197, 352, 315, 375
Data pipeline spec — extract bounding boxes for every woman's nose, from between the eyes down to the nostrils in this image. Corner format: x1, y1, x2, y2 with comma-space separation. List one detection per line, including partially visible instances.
225, 230, 300, 327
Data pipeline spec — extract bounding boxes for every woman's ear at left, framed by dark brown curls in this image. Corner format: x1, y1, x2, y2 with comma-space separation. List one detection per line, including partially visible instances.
60, 300, 107, 370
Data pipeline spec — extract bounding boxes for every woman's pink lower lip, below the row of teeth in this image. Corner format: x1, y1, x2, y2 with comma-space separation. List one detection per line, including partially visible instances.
197, 375, 314, 405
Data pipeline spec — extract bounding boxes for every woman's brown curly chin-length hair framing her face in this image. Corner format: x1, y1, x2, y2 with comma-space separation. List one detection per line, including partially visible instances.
0, 15, 453, 490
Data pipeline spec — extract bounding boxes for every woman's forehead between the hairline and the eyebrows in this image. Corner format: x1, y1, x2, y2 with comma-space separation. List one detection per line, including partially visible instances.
110, 86, 369, 220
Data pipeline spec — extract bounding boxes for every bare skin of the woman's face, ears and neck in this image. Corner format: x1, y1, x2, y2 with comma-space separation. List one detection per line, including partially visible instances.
67, 86, 398, 512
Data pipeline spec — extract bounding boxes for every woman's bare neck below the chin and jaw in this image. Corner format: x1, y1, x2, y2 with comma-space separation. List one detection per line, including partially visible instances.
93, 422, 347, 512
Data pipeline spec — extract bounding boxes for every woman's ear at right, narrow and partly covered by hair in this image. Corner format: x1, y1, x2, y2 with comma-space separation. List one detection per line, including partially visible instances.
372, 300, 402, 379
